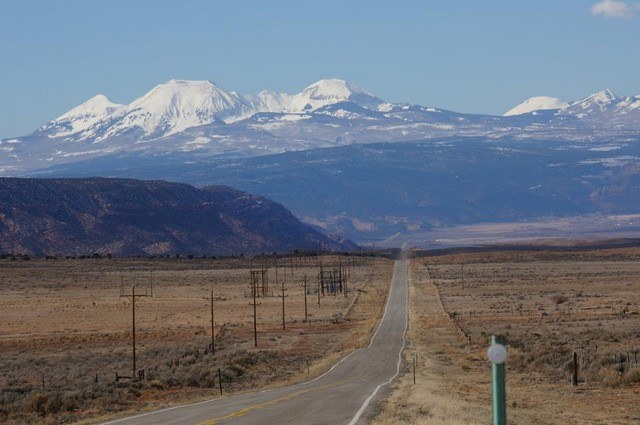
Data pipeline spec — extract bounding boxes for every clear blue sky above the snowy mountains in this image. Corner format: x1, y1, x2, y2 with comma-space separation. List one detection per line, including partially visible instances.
0, 0, 640, 137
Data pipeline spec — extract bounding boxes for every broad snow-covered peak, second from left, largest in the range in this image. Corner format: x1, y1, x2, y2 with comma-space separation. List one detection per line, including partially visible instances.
100, 80, 254, 139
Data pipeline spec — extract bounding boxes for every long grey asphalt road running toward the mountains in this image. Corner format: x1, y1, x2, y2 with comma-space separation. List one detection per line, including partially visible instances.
102, 260, 407, 425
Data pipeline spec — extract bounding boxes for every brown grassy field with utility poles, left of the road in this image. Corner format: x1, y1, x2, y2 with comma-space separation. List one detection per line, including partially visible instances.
0, 256, 392, 423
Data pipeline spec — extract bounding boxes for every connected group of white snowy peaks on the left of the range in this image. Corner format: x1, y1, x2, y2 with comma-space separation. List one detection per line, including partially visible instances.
43, 79, 384, 142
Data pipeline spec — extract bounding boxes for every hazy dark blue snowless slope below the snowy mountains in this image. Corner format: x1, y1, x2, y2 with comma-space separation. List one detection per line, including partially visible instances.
32, 138, 640, 244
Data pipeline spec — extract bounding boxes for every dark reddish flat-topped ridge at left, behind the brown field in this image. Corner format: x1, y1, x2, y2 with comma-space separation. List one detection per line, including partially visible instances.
0, 178, 357, 256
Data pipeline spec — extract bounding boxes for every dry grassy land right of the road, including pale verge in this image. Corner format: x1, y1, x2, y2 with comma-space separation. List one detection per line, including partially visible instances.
375, 249, 640, 424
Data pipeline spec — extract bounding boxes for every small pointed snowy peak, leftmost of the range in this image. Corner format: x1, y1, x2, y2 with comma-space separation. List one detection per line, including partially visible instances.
39, 94, 124, 138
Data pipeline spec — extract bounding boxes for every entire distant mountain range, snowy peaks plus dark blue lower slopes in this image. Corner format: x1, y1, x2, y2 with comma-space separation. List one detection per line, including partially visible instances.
7, 79, 640, 240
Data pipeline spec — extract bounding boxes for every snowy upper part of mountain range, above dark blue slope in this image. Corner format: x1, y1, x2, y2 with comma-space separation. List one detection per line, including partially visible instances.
0, 79, 640, 175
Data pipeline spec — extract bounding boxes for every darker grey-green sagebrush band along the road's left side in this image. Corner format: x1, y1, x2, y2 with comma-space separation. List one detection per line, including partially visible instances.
0, 346, 316, 424
